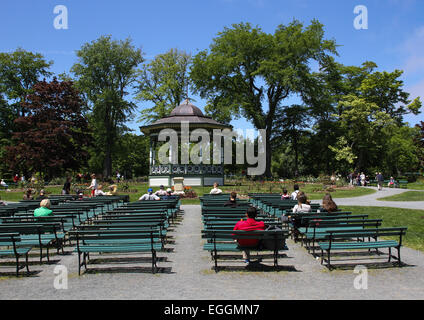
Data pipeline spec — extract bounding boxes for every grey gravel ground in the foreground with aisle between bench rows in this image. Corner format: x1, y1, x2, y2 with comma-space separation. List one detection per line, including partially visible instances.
0, 206, 424, 300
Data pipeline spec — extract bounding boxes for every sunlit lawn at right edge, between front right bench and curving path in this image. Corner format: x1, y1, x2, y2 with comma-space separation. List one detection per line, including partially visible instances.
341, 206, 424, 251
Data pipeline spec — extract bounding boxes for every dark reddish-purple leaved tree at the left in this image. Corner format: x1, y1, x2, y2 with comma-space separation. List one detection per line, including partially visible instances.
7, 79, 90, 178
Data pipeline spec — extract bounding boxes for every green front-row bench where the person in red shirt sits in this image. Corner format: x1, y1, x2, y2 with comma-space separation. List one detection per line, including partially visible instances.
202, 229, 288, 272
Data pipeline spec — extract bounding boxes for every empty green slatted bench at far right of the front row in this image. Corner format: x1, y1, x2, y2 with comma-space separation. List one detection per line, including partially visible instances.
318, 227, 407, 270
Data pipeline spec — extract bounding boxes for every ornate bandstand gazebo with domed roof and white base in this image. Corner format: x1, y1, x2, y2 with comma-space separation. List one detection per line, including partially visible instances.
140, 99, 232, 187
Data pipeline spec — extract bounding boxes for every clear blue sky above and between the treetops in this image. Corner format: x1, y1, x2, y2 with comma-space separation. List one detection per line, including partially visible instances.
0, 0, 424, 133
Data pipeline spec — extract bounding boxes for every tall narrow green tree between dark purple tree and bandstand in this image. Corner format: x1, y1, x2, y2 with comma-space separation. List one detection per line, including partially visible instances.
71, 36, 143, 177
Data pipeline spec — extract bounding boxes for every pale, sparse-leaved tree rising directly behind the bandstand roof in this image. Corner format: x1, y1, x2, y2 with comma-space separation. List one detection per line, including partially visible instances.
136, 49, 191, 122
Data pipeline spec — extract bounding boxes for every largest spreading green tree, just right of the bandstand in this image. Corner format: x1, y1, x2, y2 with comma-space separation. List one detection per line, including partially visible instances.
191, 20, 336, 177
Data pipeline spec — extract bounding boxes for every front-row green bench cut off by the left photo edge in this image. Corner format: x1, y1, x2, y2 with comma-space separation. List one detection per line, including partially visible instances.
0, 232, 32, 277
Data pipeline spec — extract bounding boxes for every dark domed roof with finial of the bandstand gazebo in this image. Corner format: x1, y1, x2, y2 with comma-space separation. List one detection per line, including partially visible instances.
140, 99, 232, 135
